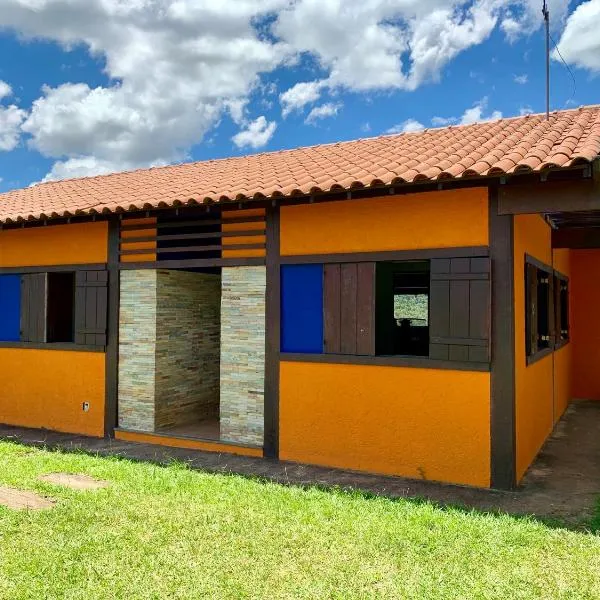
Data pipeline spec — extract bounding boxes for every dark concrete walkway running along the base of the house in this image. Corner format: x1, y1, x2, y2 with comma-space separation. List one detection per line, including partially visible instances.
0, 402, 600, 525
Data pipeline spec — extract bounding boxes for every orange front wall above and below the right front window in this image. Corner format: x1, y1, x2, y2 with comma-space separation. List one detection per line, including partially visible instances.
280, 189, 490, 487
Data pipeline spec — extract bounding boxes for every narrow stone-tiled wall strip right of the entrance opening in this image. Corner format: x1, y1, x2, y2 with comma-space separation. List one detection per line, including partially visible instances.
221, 266, 266, 445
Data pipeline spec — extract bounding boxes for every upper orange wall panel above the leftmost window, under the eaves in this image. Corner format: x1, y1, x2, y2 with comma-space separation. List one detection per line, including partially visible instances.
0, 221, 108, 267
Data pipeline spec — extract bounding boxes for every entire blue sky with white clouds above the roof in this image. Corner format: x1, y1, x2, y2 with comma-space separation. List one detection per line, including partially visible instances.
0, 0, 600, 191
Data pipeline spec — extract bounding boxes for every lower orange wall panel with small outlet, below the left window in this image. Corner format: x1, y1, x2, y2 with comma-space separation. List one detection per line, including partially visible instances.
0, 348, 104, 437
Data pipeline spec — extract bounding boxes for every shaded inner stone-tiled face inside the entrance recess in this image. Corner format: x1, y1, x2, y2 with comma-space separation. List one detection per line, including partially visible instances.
155, 270, 221, 429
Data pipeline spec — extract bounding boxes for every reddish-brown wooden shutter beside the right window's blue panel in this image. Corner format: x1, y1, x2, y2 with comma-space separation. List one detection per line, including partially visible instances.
323, 262, 375, 355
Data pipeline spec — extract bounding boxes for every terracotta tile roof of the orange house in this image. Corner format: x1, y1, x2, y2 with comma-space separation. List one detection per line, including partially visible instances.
0, 105, 600, 223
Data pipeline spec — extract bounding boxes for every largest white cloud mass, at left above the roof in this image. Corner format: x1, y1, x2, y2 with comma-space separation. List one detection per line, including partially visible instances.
0, 0, 291, 177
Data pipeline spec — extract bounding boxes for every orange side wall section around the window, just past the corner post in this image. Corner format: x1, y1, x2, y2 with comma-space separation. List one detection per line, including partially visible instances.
514, 215, 554, 480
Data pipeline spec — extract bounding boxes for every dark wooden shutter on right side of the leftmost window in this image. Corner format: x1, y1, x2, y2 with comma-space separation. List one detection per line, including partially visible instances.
75, 271, 108, 346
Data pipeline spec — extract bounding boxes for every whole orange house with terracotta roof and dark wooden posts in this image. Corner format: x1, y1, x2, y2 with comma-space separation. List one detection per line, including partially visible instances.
0, 107, 600, 489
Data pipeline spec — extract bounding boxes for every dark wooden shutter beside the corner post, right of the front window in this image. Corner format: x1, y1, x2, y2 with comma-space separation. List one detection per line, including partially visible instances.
429, 257, 490, 362
